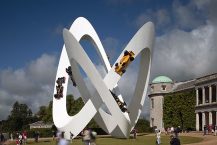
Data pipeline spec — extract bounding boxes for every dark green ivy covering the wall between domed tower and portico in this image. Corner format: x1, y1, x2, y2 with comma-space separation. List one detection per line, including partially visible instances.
163, 90, 196, 130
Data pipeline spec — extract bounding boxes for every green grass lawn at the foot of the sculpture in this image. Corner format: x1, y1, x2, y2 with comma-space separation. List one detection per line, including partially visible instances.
8, 135, 203, 145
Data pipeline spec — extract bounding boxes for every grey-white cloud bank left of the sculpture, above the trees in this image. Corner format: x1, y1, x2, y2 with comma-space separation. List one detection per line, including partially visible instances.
0, 54, 57, 120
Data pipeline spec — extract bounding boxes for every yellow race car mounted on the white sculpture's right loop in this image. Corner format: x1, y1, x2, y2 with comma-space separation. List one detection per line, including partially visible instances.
115, 50, 135, 76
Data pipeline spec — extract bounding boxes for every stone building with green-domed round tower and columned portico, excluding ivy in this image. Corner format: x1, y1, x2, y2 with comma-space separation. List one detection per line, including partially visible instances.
149, 73, 217, 131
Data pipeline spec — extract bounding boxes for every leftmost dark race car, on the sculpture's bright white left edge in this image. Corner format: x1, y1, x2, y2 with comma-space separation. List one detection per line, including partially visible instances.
54, 77, 66, 99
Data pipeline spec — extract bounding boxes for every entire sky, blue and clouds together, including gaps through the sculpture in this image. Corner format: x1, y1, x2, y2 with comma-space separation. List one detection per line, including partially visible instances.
0, 0, 217, 120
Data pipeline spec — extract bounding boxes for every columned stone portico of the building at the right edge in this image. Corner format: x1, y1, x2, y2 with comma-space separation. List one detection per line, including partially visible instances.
195, 74, 217, 130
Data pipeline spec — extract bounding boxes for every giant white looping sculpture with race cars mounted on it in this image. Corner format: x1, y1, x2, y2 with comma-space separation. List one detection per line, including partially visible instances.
53, 17, 154, 139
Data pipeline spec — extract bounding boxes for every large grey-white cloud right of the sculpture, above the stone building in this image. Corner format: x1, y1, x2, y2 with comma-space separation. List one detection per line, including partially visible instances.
152, 24, 217, 80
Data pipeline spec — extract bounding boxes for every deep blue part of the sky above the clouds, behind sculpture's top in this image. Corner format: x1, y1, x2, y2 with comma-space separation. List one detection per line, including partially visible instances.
0, 0, 184, 69
